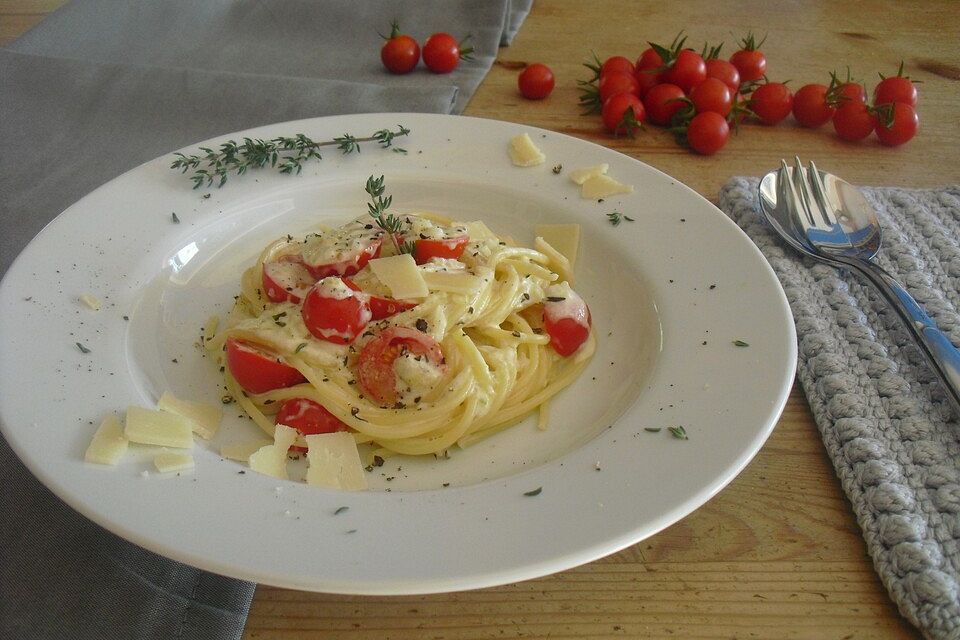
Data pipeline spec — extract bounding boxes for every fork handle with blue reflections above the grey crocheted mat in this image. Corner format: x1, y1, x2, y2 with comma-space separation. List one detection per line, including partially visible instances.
850, 260, 960, 417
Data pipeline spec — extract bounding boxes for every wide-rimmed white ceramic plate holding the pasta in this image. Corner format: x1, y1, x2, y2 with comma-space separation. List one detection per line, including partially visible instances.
0, 114, 796, 594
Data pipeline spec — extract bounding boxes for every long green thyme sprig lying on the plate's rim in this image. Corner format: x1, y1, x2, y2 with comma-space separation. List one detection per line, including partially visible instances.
170, 125, 410, 189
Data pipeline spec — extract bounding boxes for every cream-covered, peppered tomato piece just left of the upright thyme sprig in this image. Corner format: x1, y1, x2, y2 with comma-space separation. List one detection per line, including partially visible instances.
301, 221, 383, 280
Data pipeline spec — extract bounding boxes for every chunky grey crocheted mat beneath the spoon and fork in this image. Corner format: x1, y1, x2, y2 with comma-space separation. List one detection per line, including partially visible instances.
720, 178, 960, 639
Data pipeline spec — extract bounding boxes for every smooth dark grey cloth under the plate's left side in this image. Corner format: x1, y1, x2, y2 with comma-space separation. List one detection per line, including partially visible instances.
0, 0, 531, 640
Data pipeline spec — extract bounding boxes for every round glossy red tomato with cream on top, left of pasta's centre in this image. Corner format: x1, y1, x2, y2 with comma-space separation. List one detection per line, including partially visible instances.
300, 277, 373, 344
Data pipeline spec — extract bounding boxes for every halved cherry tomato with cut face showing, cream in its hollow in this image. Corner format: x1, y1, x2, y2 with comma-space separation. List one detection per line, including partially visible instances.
356, 326, 445, 406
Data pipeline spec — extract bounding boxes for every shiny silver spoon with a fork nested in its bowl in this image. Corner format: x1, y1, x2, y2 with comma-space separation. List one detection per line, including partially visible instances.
759, 160, 960, 416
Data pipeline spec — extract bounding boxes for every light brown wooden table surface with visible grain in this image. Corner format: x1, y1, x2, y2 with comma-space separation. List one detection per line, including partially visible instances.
7, 0, 960, 640
